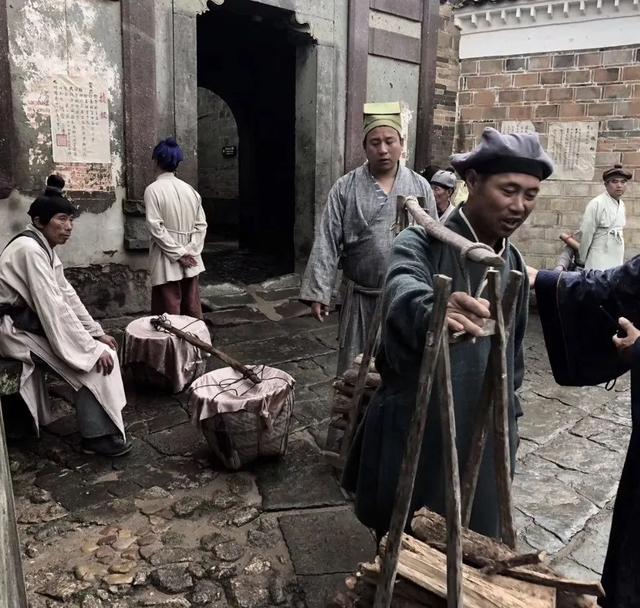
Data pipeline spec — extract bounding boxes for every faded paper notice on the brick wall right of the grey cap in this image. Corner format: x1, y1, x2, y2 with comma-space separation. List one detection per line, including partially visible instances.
547, 122, 598, 181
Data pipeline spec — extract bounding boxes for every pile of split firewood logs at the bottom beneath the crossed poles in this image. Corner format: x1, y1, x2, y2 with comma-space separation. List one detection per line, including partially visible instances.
330, 509, 603, 608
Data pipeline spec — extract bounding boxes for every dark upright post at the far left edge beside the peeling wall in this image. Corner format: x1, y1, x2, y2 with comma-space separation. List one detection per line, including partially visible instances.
0, 0, 16, 199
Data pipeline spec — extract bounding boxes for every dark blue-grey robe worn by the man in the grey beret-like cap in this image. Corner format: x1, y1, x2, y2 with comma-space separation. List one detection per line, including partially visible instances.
343, 209, 529, 537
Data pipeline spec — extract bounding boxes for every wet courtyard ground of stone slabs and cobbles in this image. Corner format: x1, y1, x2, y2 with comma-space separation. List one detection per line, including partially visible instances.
3, 298, 630, 608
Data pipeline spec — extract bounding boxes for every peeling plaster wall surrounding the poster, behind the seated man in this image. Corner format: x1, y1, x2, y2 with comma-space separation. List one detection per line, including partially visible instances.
0, 0, 146, 310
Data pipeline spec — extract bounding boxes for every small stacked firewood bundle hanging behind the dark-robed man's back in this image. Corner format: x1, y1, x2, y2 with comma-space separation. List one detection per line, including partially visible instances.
325, 355, 380, 466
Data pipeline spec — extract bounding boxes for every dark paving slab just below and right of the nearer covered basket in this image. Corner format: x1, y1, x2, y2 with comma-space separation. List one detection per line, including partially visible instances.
255, 438, 345, 511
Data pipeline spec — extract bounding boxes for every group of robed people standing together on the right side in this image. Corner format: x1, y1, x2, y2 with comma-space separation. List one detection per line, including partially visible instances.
301, 102, 640, 608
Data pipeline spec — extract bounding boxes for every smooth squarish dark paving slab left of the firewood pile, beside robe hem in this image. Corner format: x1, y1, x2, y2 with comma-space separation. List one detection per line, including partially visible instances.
278, 508, 376, 576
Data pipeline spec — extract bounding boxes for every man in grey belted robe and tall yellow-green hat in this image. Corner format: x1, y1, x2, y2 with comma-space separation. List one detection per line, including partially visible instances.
300, 103, 437, 375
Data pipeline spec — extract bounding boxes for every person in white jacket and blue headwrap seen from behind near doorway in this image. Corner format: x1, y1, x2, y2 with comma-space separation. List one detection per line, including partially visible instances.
144, 137, 207, 319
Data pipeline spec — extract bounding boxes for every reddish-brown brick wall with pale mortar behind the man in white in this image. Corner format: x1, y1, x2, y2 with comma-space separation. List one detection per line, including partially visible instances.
456, 45, 640, 267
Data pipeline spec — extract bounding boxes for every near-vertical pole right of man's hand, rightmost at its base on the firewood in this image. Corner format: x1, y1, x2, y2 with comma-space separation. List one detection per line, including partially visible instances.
487, 270, 516, 547
